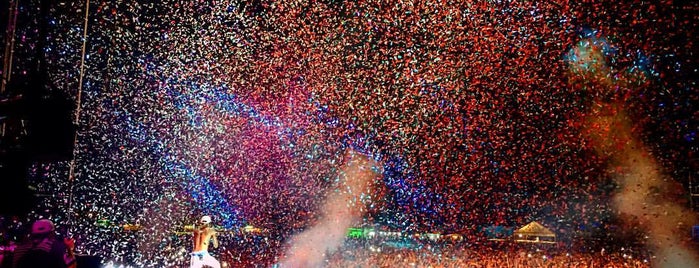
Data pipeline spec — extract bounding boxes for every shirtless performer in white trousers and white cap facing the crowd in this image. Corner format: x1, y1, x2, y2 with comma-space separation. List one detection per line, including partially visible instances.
190, 216, 221, 268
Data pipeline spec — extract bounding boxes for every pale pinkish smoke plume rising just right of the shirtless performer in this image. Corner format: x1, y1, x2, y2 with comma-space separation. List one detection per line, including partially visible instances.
281, 151, 377, 267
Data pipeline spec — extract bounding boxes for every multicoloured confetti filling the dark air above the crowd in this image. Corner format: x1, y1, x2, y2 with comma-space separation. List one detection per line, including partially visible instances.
2, 0, 699, 267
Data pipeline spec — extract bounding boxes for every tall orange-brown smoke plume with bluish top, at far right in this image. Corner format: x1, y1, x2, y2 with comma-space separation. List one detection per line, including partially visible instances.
570, 37, 699, 267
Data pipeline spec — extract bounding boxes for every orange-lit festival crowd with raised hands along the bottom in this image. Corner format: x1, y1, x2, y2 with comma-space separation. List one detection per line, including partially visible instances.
211, 242, 656, 268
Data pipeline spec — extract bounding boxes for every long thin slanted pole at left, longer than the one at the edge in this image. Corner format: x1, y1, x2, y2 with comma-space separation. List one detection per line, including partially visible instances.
67, 0, 90, 233
